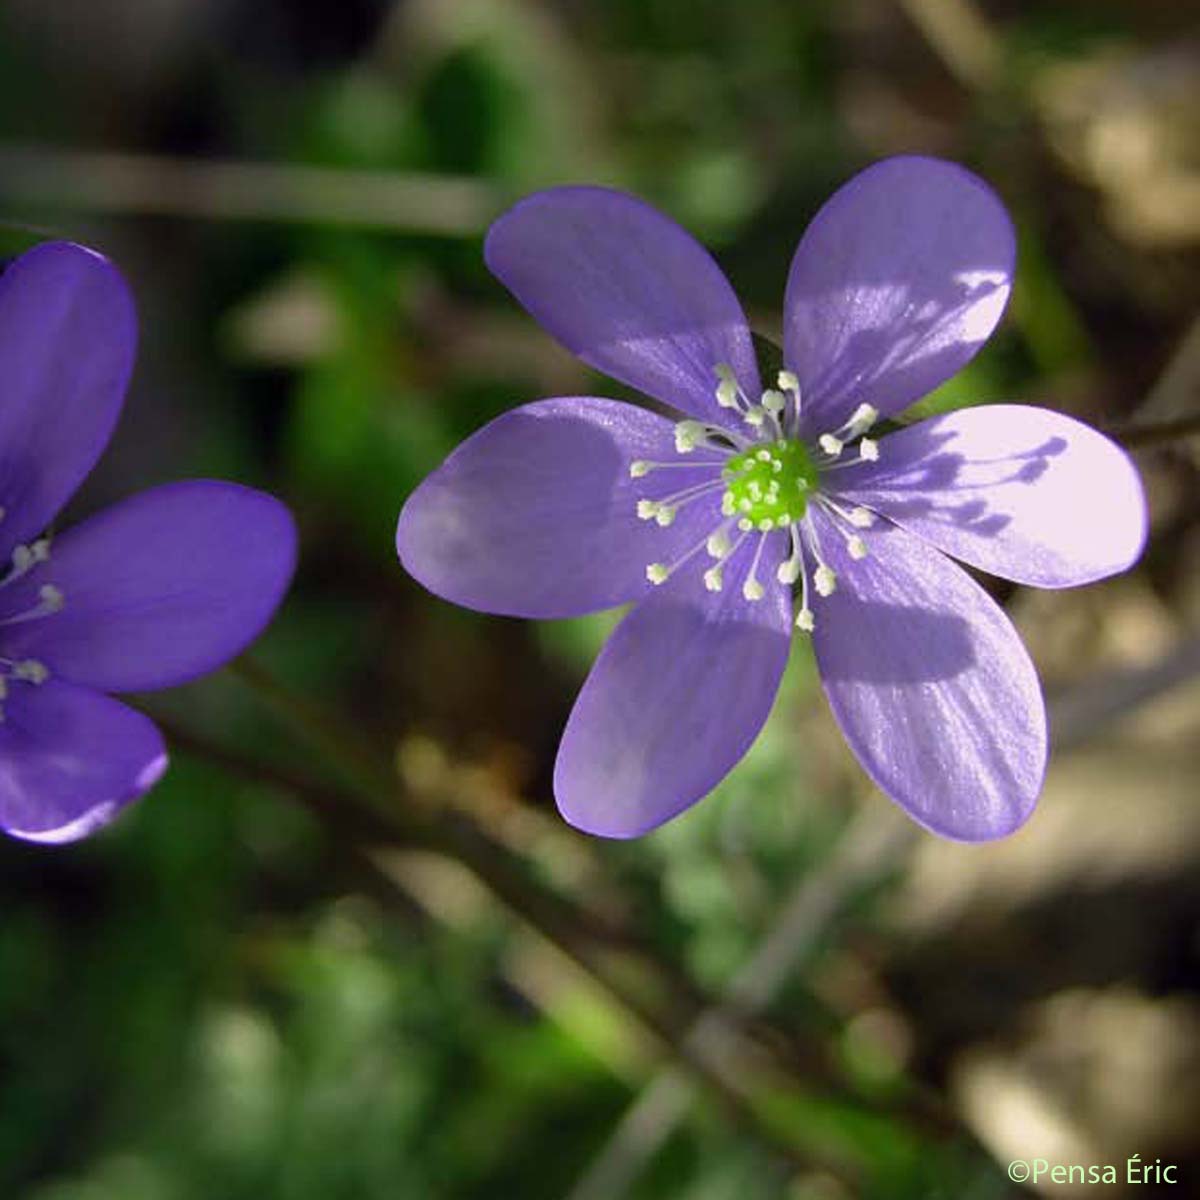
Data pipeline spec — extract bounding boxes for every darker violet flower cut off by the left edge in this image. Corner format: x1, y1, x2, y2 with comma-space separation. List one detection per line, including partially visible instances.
0, 242, 295, 842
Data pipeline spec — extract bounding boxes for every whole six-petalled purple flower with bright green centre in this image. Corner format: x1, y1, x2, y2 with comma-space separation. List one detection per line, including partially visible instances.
397, 157, 1146, 841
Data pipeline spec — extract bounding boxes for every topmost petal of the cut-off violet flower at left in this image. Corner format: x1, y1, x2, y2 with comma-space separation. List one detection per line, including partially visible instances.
0, 241, 137, 558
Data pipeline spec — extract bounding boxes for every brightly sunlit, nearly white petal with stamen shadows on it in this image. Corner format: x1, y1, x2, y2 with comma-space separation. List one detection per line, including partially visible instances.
839, 404, 1146, 588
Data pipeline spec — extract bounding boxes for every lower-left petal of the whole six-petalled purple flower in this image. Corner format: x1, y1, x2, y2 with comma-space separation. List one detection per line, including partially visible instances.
554, 534, 792, 838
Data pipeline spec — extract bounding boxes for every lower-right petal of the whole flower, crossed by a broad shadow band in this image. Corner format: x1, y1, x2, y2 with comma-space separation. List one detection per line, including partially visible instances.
812, 524, 1046, 841
